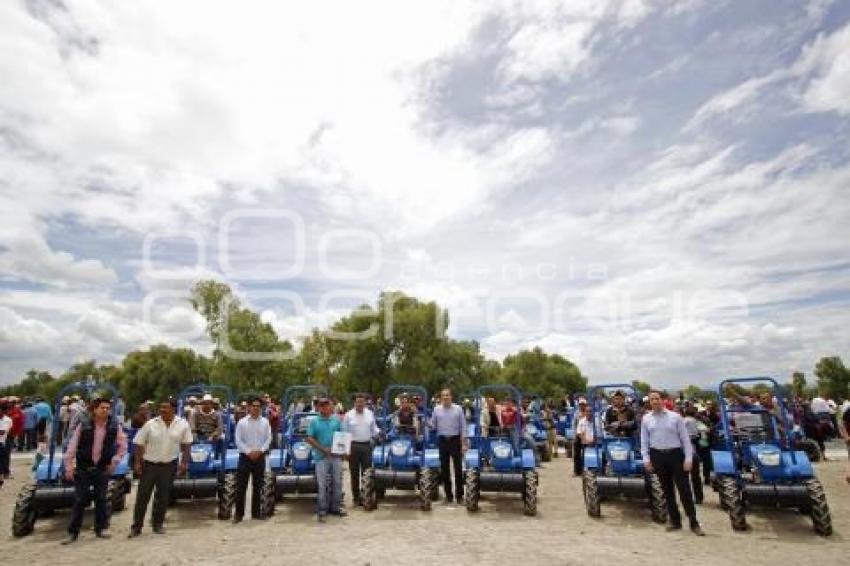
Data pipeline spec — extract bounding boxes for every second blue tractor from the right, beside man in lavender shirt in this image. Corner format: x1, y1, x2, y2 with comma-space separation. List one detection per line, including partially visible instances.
582, 383, 667, 523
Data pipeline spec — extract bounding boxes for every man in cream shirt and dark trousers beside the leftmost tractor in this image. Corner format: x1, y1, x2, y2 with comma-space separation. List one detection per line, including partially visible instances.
129, 399, 192, 538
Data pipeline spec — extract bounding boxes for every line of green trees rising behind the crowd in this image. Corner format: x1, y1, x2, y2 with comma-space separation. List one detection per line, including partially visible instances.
0, 280, 587, 407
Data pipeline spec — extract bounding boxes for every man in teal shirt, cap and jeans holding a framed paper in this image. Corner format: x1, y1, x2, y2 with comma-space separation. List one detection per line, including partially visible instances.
307, 397, 347, 523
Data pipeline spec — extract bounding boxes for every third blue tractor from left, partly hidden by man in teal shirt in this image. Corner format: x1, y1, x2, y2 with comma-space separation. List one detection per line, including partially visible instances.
263, 385, 328, 517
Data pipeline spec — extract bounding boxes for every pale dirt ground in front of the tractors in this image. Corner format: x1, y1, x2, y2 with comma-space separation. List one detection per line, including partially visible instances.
0, 444, 850, 566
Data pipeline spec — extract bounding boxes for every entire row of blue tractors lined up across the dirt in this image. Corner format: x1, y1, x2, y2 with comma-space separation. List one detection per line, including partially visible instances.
12, 378, 832, 536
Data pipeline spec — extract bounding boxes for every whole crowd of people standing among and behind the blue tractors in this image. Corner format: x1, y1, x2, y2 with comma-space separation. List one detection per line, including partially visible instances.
0, 389, 850, 544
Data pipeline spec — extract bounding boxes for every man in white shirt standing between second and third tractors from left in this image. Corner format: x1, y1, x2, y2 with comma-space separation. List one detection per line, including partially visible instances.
233, 397, 272, 523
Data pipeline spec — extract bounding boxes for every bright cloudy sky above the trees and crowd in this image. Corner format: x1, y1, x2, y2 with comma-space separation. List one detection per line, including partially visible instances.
0, 0, 850, 386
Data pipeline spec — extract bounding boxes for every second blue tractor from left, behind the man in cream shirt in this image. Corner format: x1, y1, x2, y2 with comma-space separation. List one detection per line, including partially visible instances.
171, 383, 239, 520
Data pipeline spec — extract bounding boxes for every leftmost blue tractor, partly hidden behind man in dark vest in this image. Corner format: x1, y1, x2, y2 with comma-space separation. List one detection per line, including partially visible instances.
12, 382, 130, 537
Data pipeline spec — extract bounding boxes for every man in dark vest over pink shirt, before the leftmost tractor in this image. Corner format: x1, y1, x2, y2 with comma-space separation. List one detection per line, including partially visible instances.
62, 399, 127, 544
